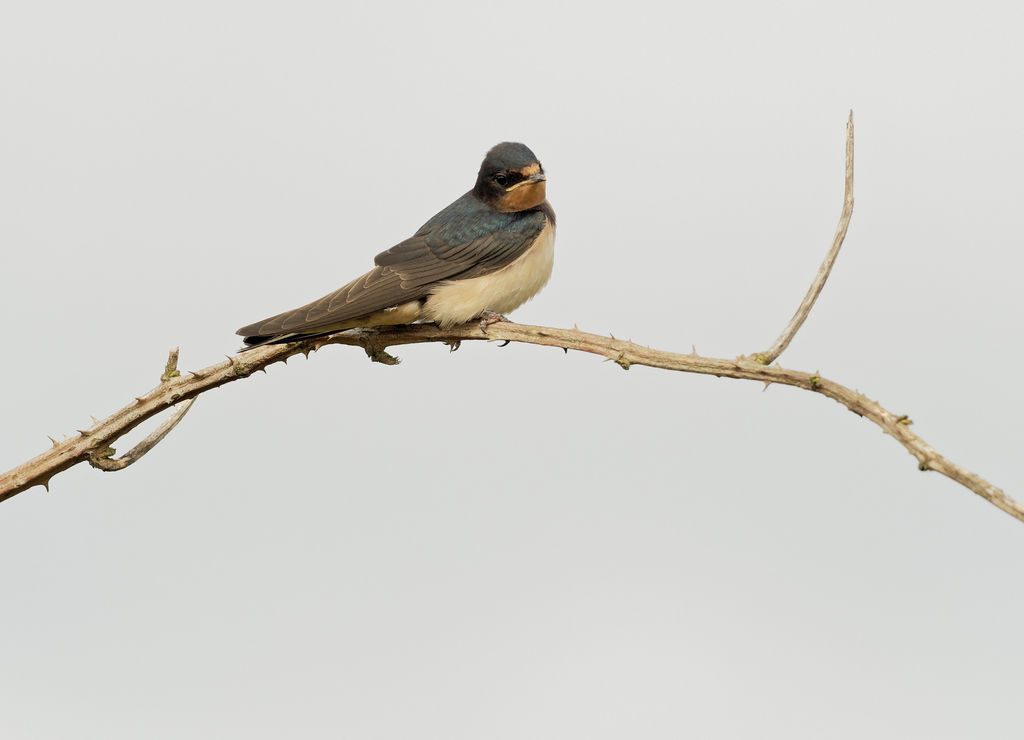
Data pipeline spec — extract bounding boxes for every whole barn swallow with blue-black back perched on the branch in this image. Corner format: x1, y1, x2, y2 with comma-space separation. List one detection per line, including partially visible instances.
238, 141, 555, 349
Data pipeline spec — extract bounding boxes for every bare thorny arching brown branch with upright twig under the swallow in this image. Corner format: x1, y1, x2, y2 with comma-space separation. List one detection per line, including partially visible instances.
0, 117, 1024, 522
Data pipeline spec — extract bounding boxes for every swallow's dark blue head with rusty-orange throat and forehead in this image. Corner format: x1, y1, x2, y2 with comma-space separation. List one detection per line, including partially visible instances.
473, 141, 547, 212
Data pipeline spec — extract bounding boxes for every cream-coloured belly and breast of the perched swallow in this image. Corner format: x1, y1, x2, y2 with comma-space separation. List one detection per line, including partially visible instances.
420, 223, 555, 329
